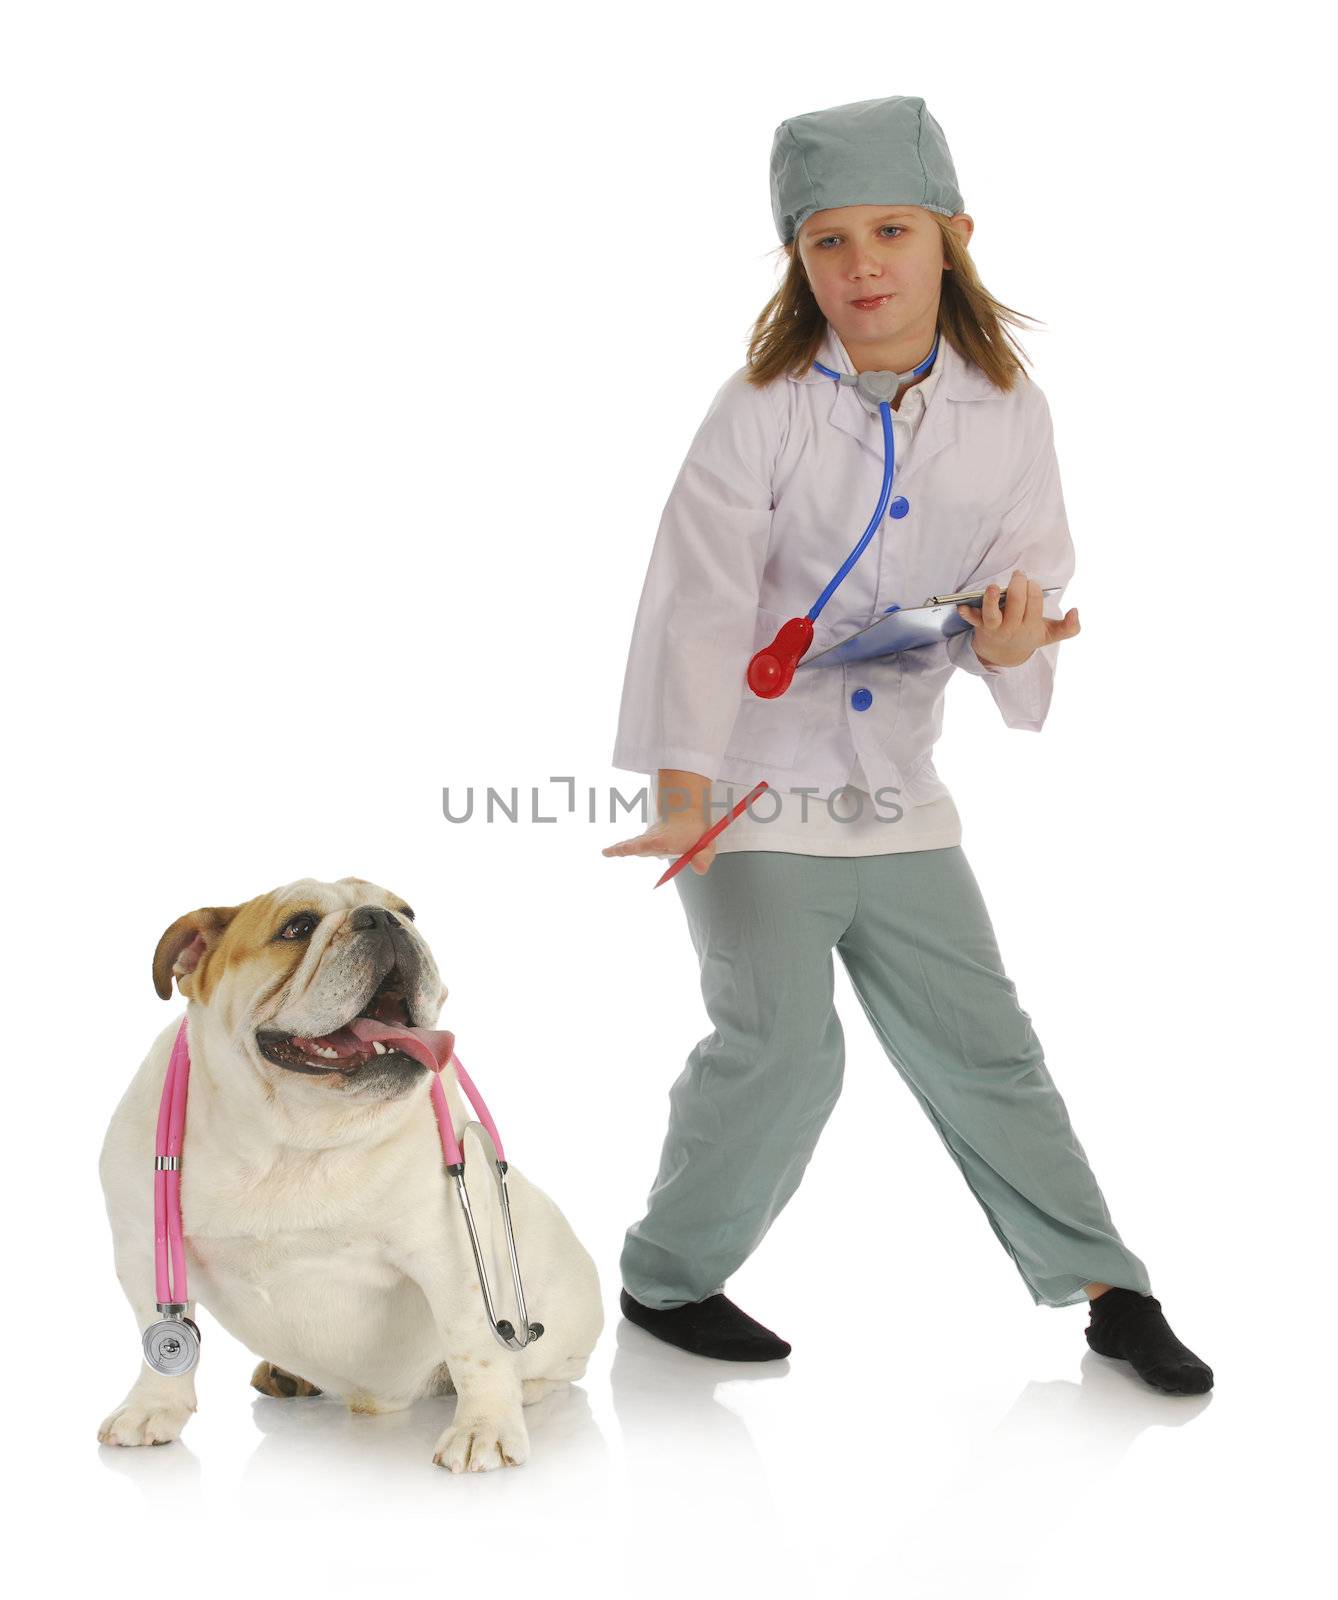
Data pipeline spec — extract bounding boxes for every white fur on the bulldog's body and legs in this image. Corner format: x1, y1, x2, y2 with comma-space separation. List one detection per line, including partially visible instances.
98, 885, 603, 1472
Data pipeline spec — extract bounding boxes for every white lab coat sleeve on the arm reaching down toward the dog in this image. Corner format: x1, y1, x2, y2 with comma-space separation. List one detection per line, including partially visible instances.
613, 370, 781, 778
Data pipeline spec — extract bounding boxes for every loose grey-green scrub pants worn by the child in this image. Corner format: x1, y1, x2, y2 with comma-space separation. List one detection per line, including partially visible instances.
619, 845, 1151, 1309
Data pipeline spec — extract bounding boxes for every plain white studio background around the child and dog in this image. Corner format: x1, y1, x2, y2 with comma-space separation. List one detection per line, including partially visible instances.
0, 3, 1335, 1597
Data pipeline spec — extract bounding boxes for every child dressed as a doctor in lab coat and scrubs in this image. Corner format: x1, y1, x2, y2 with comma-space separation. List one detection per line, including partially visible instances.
603, 96, 1213, 1394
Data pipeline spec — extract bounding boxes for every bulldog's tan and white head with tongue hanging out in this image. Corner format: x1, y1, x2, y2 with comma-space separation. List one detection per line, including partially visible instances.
154, 878, 450, 1099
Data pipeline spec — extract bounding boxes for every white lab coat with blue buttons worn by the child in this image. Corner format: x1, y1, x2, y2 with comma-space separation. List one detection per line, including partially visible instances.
613, 323, 1074, 805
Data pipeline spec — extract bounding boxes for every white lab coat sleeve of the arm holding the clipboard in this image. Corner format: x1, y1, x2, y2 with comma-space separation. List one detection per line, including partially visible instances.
947, 389, 1074, 733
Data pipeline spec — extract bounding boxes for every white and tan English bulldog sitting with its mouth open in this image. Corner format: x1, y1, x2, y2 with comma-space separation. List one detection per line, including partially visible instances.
98, 878, 603, 1472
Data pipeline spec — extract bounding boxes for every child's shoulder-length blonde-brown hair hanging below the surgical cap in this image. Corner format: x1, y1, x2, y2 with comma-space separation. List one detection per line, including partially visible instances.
747, 211, 1044, 394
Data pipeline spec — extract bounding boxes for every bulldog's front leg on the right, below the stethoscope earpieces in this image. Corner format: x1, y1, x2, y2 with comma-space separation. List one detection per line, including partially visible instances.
402, 1251, 530, 1472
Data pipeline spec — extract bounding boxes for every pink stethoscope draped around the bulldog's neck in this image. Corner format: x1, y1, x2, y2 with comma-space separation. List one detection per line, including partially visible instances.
142, 1018, 544, 1378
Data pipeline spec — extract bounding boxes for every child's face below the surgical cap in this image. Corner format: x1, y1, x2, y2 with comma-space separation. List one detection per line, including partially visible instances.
792, 205, 975, 346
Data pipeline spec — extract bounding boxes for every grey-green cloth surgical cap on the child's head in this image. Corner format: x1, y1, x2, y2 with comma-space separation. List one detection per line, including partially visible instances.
771, 94, 963, 245
